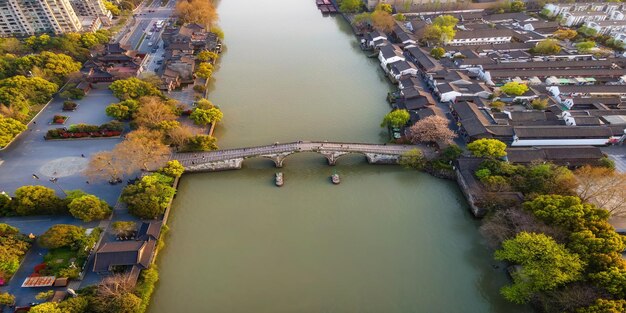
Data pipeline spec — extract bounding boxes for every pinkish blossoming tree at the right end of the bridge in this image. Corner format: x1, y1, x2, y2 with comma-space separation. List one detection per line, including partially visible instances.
408, 115, 456, 144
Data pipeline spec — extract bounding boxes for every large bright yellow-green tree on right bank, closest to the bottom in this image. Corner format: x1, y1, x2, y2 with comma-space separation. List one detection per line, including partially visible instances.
495, 232, 584, 304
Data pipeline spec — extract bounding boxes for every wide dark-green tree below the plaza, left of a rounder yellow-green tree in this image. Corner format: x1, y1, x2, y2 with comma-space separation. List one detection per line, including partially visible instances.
12, 186, 64, 215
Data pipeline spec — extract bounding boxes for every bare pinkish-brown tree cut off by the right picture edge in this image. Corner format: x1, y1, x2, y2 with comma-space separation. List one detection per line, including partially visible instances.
574, 165, 626, 216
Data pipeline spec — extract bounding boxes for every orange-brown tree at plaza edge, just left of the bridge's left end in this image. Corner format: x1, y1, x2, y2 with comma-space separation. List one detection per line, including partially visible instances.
113, 128, 170, 171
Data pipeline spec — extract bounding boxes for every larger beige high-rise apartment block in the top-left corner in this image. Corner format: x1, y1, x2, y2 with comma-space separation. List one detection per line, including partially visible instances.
0, 0, 82, 36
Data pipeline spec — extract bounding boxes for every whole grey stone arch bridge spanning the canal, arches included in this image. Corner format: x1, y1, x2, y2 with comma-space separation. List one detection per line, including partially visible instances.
172, 141, 417, 172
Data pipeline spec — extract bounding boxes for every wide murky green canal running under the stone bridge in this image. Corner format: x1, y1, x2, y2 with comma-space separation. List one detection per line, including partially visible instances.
150, 0, 526, 313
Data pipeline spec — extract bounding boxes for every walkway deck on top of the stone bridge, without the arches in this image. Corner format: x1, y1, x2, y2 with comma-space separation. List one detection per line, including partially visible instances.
172, 141, 416, 167
